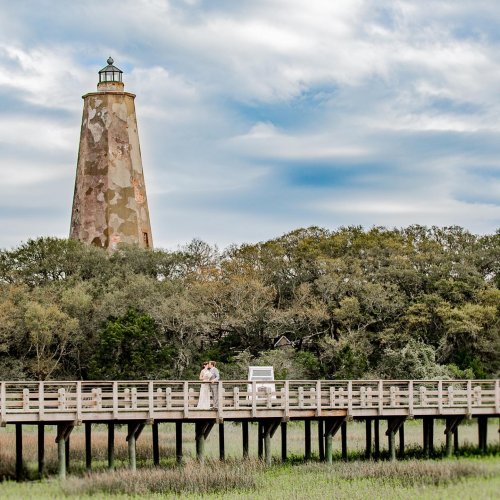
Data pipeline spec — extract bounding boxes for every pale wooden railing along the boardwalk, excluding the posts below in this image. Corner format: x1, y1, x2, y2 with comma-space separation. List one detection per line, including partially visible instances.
0, 380, 500, 425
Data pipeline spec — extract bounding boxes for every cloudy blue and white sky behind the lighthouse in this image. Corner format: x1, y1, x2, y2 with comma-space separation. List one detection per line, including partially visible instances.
0, 0, 500, 250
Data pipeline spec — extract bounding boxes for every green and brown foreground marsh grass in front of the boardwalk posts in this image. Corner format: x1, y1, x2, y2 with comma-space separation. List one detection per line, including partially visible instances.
0, 457, 500, 500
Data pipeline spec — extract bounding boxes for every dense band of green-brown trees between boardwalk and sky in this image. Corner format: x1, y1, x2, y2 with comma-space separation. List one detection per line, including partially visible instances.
0, 226, 500, 380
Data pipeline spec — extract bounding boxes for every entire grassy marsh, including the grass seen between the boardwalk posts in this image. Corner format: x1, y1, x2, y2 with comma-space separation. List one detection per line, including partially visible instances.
0, 419, 500, 499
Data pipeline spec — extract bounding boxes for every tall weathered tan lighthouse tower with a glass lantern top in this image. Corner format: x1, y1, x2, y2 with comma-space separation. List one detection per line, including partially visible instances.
70, 57, 153, 250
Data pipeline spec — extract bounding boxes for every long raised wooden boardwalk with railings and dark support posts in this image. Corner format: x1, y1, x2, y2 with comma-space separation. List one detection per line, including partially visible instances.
0, 380, 500, 477
